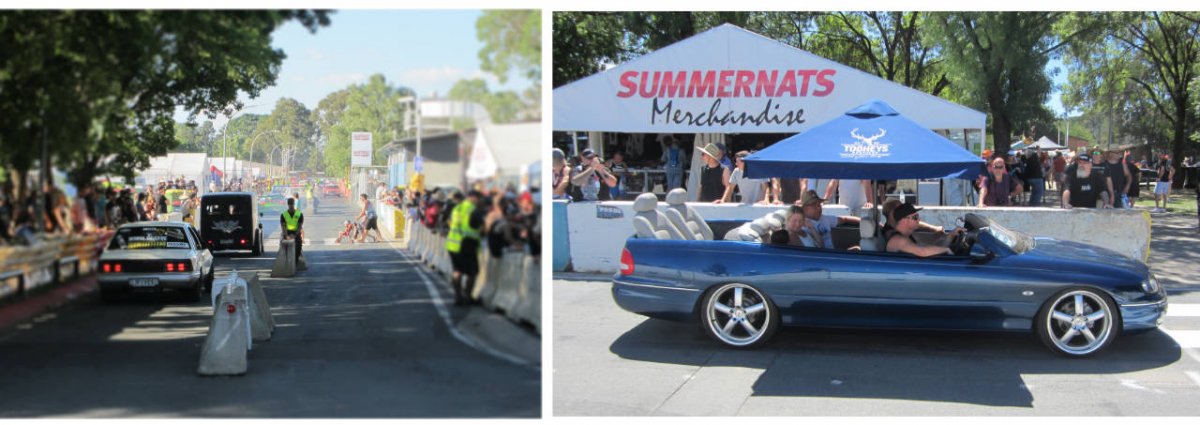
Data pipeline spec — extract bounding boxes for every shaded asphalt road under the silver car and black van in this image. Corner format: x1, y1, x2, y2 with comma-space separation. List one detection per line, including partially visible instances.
0, 194, 541, 418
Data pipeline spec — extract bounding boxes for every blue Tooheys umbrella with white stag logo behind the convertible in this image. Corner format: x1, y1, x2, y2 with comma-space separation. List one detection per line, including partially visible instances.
745, 100, 984, 180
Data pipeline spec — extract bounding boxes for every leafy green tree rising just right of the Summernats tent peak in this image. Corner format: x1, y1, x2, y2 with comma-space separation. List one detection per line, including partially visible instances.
925, 12, 1094, 152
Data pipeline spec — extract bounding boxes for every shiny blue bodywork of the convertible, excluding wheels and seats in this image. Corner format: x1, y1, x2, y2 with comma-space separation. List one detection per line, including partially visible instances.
612, 226, 1166, 331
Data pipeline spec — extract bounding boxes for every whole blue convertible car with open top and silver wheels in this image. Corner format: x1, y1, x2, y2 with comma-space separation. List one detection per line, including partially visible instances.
612, 200, 1166, 357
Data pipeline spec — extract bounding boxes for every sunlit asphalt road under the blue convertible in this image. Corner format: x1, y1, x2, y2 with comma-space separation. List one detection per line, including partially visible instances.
553, 215, 1200, 417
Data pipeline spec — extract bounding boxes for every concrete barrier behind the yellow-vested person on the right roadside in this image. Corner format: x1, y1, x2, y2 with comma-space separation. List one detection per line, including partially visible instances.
407, 217, 541, 334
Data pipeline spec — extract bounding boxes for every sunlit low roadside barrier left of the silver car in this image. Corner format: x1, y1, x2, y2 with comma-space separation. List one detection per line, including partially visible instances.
0, 231, 113, 300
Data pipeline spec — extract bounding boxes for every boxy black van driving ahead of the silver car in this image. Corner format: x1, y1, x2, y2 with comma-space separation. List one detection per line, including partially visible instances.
198, 192, 263, 256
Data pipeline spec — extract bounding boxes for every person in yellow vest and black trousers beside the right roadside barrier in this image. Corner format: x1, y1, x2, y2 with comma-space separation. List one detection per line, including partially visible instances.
446, 191, 484, 305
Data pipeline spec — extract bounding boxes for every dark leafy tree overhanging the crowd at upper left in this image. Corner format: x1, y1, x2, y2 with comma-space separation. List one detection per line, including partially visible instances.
0, 11, 329, 194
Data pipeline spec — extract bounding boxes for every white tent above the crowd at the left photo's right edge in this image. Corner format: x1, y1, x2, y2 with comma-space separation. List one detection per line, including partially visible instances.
466, 122, 541, 181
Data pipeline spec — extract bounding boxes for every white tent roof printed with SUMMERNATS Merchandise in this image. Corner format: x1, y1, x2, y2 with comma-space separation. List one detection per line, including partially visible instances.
553, 24, 986, 133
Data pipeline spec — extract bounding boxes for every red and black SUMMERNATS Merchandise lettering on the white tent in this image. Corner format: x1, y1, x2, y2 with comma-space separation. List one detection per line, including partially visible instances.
616, 68, 838, 127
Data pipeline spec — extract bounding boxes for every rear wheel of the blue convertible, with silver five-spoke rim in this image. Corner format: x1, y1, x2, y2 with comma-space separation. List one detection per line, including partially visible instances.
700, 283, 779, 348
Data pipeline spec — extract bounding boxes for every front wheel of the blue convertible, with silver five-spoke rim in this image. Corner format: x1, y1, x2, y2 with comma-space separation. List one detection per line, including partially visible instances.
1033, 287, 1121, 358
